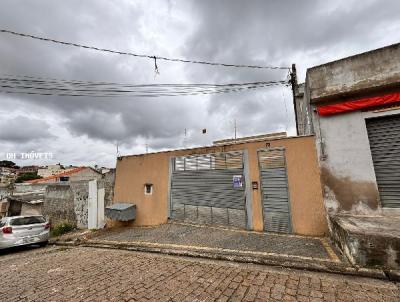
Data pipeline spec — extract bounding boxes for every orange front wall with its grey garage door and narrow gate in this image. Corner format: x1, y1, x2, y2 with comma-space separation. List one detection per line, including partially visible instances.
114, 133, 327, 235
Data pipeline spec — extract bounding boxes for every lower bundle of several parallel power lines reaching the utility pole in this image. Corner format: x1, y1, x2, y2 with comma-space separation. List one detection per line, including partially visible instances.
0, 75, 287, 97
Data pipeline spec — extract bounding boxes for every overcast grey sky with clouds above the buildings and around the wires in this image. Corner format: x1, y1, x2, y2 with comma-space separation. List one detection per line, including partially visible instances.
0, 0, 400, 167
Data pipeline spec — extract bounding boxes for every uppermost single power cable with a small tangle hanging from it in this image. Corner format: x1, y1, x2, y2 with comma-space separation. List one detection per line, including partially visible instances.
0, 29, 290, 71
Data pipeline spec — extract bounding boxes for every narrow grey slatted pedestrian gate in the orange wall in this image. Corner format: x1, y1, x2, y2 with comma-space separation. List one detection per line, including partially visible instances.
258, 149, 292, 233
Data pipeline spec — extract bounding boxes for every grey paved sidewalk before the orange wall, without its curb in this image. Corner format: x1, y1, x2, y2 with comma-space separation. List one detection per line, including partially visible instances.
93, 223, 340, 262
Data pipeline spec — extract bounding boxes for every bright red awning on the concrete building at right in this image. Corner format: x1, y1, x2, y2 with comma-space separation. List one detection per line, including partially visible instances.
317, 92, 400, 116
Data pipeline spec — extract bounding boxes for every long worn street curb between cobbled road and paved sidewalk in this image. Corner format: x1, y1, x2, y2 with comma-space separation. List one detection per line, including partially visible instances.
54, 240, 389, 280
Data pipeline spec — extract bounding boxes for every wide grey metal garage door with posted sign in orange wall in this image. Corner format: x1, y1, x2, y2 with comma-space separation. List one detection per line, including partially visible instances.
170, 152, 246, 228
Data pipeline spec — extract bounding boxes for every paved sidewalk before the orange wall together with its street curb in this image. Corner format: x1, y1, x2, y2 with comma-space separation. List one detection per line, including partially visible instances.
50, 223, 387, 279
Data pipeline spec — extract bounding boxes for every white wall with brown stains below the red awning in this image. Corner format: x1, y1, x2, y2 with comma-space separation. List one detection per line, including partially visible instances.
313, 106, 400, 215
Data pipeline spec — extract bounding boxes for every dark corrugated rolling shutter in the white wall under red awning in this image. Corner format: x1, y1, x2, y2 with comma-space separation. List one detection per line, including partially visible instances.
366, 115, 400, 208
